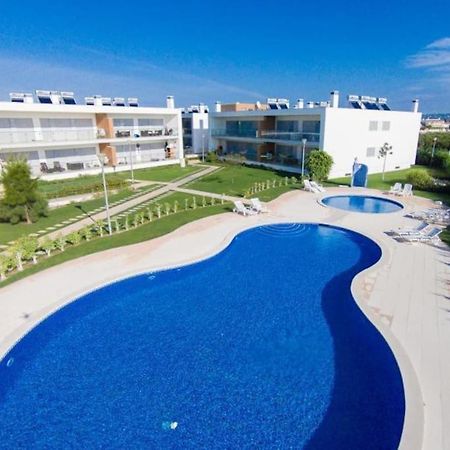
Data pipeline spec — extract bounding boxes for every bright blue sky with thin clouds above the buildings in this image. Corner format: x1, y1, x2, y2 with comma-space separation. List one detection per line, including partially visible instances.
0, 0, 450, 112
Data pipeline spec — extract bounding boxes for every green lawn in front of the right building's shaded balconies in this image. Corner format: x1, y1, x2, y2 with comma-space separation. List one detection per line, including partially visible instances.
186, 165, 294, 201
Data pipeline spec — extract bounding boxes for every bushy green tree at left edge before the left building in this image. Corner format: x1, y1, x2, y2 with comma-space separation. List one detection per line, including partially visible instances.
0, 160, 48, 224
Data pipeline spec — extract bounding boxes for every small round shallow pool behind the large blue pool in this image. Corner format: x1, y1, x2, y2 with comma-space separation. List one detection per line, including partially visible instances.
322, 195, 403, 214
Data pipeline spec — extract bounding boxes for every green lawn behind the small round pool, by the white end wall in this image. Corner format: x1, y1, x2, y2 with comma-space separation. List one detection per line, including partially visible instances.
326, 166, 450, 203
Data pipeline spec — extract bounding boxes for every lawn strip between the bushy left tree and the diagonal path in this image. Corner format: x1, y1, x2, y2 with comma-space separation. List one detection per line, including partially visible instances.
0, 186, 157, 245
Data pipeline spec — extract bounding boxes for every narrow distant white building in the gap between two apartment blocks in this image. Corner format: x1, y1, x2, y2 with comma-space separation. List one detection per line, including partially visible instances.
181, 103, 209, 155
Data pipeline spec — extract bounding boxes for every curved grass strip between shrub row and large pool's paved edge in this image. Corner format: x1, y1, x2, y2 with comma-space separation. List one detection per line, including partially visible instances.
0, 203, 231, 288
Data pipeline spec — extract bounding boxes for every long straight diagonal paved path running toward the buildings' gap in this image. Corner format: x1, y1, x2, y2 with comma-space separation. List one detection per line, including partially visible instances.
43, 166, 218, 239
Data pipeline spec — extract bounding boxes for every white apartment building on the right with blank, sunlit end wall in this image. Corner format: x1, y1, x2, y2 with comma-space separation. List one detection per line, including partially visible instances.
210, 91, 421, 178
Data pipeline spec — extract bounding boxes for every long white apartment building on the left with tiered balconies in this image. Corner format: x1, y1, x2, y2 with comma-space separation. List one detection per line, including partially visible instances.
0, 91, 183, 178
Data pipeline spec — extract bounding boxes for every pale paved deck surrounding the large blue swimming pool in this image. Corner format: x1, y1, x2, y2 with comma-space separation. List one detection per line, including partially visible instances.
0, 188, 450, 450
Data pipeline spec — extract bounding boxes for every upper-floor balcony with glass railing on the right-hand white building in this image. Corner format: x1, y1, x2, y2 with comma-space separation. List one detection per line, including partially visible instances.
211, 129, 320, 145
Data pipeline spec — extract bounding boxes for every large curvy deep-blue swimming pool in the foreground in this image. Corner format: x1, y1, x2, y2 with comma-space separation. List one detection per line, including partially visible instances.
0, 224, 405, 450
